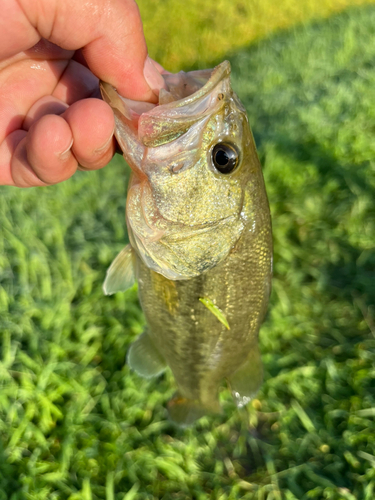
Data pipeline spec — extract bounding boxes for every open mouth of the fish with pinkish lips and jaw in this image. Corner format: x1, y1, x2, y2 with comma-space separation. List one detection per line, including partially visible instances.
100, 61, 232, 147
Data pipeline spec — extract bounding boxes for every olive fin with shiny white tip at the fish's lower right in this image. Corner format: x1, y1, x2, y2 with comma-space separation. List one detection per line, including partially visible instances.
228, 346, 263, 408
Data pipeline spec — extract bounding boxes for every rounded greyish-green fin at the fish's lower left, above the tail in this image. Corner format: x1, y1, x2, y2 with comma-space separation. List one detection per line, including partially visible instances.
127, 332, 167, 378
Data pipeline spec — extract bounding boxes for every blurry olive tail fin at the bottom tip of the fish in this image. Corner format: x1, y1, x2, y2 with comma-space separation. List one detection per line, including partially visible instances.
168, 392, 221, 427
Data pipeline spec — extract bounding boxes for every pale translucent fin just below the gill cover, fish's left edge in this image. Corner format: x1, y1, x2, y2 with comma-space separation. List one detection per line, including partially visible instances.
103, 245, 135, 295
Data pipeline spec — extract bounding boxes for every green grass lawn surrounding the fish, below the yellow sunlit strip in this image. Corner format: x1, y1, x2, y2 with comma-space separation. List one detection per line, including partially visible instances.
0, 3, 375, 500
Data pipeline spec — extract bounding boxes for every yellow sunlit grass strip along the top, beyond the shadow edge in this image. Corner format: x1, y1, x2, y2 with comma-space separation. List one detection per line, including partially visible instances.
138, 0, 374, 71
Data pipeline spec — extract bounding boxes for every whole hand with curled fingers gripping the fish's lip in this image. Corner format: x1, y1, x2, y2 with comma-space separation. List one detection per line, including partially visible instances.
0, 0, 163, 187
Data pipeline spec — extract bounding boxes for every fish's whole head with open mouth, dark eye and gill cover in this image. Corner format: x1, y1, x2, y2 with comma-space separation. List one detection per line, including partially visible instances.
101, 61, 260, 280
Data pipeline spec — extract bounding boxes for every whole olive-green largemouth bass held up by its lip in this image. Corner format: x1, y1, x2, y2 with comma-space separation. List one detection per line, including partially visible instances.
101, 61, 272, 425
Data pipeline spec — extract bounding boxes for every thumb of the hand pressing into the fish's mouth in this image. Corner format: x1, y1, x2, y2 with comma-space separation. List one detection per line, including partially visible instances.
15, 0, 164, 101
